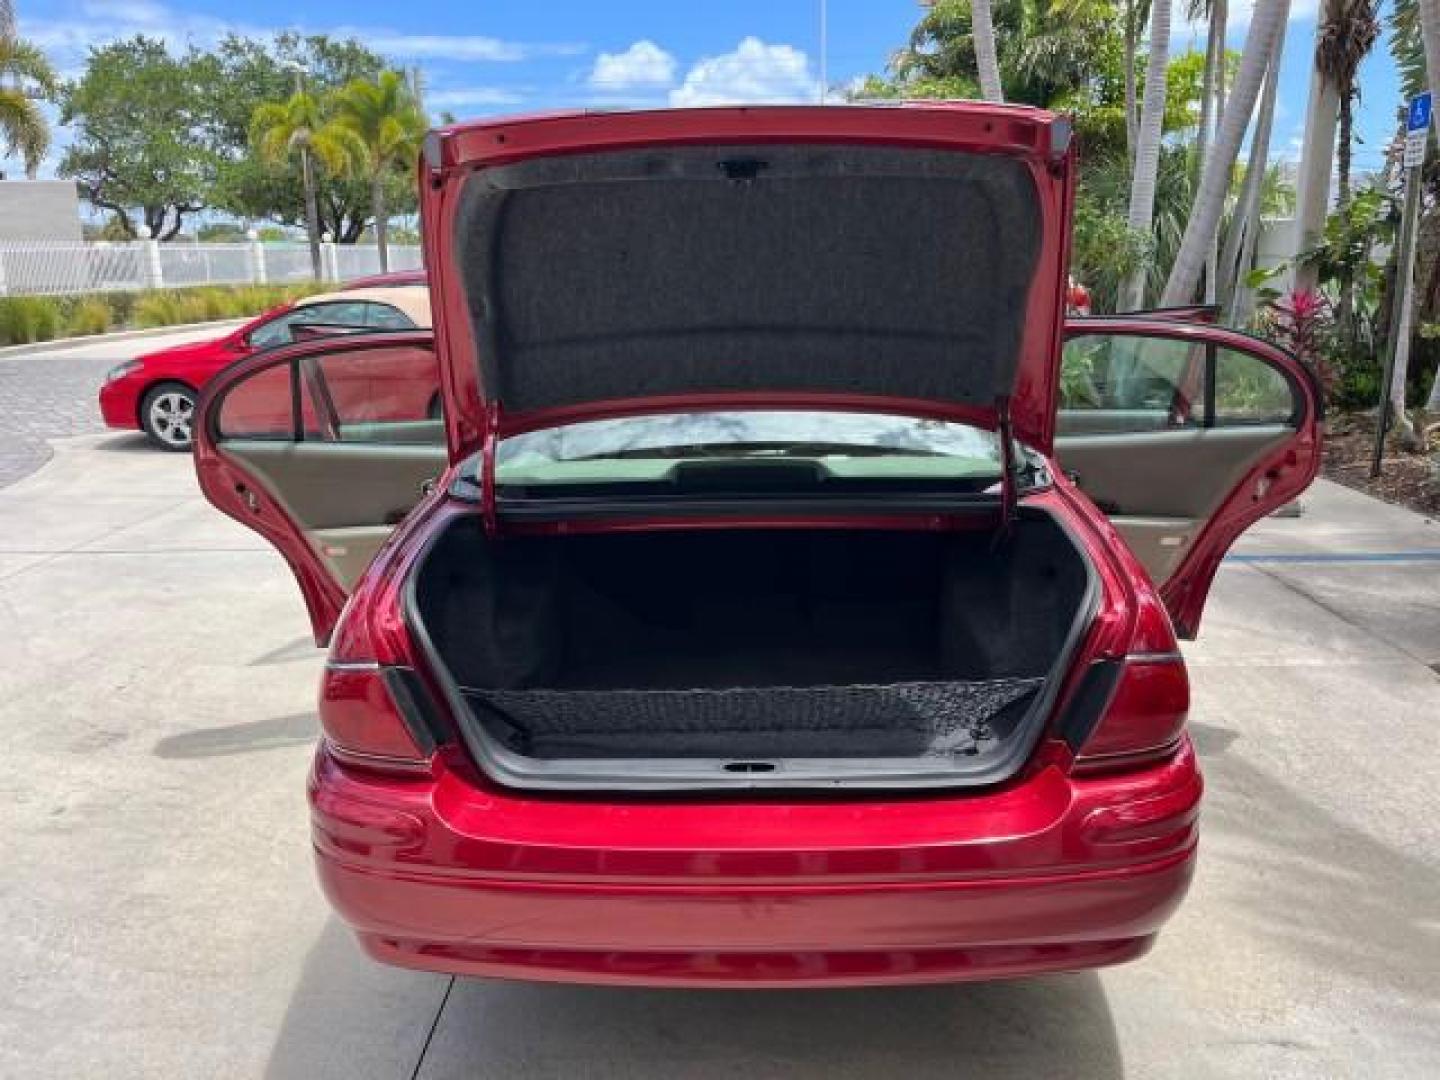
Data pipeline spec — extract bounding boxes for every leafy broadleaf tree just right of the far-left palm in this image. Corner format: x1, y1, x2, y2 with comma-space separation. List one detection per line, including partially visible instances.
58, 35, 216, 240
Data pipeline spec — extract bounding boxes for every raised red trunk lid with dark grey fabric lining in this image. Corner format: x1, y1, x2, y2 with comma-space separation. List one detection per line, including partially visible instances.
422, 104, 1073, 459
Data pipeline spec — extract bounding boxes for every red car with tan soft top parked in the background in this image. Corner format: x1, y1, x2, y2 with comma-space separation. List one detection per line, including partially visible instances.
99, 285, 439, 451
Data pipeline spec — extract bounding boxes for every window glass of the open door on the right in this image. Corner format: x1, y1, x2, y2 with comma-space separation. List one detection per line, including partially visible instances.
1058, 334, 1296, 435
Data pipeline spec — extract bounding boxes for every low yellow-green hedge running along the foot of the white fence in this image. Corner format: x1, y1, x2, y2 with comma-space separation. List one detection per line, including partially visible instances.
0, 282, 327, 346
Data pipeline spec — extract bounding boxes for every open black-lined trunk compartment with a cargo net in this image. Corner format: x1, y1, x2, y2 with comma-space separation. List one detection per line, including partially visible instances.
410, 511, 1094, 788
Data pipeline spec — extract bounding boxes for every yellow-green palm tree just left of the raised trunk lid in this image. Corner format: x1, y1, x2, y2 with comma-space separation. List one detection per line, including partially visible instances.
336, 71, 426, 272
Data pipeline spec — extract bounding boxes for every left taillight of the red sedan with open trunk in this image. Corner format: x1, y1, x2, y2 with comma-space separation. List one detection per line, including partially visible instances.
320, 589, 435, 773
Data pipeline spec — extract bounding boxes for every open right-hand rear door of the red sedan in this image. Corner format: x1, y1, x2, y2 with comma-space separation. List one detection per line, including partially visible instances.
1056, 318, 1320, 638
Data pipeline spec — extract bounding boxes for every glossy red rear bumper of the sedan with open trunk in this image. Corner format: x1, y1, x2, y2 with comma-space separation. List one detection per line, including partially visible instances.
312, 747, 1200, 986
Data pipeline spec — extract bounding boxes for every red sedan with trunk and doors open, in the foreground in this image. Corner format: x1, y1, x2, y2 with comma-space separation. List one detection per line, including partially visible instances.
196, 104, 1318, 986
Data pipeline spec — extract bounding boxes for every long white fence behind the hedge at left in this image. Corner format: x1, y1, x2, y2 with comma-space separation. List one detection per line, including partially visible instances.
0, 240, 420, 297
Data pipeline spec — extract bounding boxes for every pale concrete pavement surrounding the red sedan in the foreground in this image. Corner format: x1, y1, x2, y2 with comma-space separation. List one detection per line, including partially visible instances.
0, 336, 1440, 1080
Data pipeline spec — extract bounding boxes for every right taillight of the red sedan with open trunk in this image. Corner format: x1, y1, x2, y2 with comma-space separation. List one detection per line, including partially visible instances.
1061, 596, 1189, 775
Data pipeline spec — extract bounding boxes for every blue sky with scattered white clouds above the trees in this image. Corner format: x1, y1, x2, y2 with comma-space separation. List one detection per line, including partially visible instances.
17, 0, 1398, 180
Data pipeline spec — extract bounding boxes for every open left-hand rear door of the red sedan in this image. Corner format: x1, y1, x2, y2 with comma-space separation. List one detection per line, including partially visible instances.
194, 331, 448, 645
